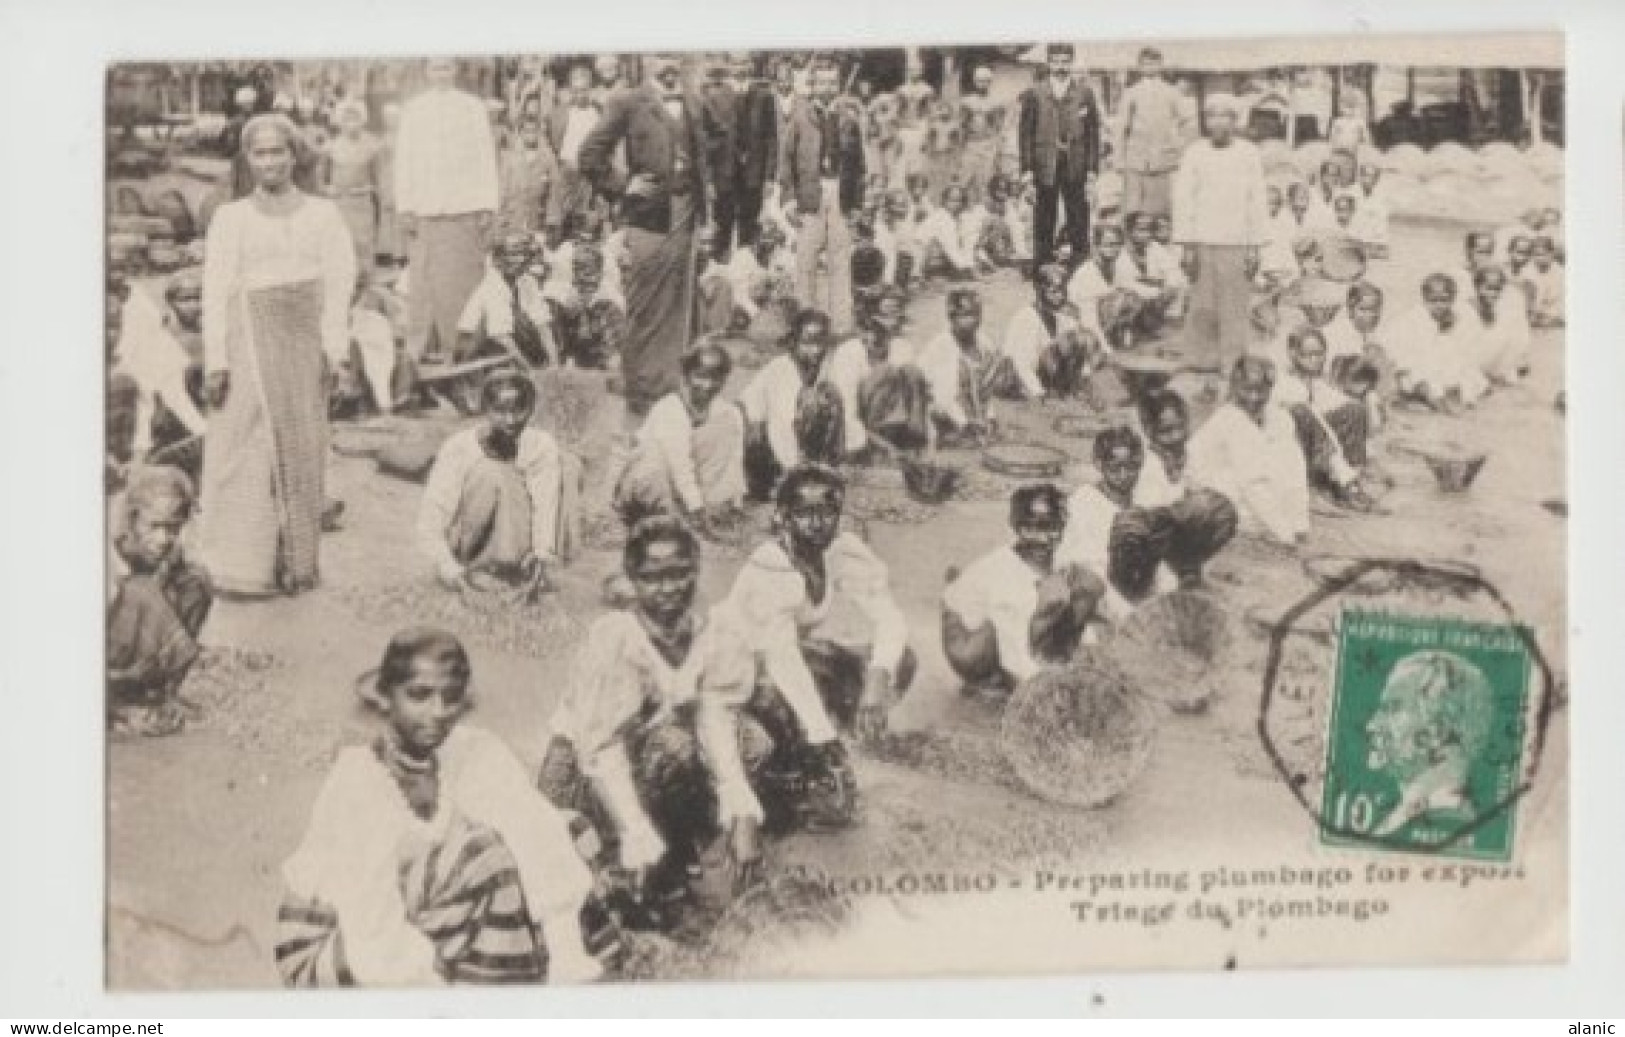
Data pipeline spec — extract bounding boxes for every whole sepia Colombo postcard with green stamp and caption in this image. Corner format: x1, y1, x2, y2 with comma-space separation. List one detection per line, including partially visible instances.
106, 33, 1570, 990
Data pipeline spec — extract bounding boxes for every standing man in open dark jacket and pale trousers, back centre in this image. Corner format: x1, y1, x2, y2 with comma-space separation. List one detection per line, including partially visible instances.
778, 65, 863, 336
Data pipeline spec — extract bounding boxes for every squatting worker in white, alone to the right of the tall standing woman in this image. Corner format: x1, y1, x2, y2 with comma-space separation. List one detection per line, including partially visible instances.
418, 371, 582, 588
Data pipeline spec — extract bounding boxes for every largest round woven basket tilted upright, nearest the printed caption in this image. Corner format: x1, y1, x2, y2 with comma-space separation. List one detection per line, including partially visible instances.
999, 650, 1157, 808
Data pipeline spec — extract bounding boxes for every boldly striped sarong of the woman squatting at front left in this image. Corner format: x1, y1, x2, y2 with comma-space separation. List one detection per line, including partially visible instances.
276, 819, 548, 987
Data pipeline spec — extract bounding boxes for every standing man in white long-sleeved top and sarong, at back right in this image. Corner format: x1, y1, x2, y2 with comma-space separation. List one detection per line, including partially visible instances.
1173, 94, 1269, 372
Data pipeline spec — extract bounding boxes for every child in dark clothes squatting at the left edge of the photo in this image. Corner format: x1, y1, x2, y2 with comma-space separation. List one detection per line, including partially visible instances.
107, 465, 215, 735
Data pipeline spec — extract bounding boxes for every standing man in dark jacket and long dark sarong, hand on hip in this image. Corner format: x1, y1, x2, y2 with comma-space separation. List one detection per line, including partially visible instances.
579, 54, 709, 418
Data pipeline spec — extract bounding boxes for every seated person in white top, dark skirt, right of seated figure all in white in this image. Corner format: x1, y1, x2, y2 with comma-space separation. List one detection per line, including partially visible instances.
1274, 327, 1372, 512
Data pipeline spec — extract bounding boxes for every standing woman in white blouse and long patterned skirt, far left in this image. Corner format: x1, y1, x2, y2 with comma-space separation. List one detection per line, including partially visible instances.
202, 115, 356, 595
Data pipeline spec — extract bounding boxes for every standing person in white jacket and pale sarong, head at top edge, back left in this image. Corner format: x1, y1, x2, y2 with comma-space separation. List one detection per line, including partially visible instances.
395, 57, 497, 361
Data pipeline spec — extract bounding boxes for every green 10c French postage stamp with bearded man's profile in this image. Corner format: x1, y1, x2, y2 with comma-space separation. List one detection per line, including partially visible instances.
1321, 610, 1531, 860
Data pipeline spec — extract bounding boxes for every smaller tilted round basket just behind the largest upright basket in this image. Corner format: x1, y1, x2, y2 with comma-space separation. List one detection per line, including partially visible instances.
1108, 590, 1232, 714
